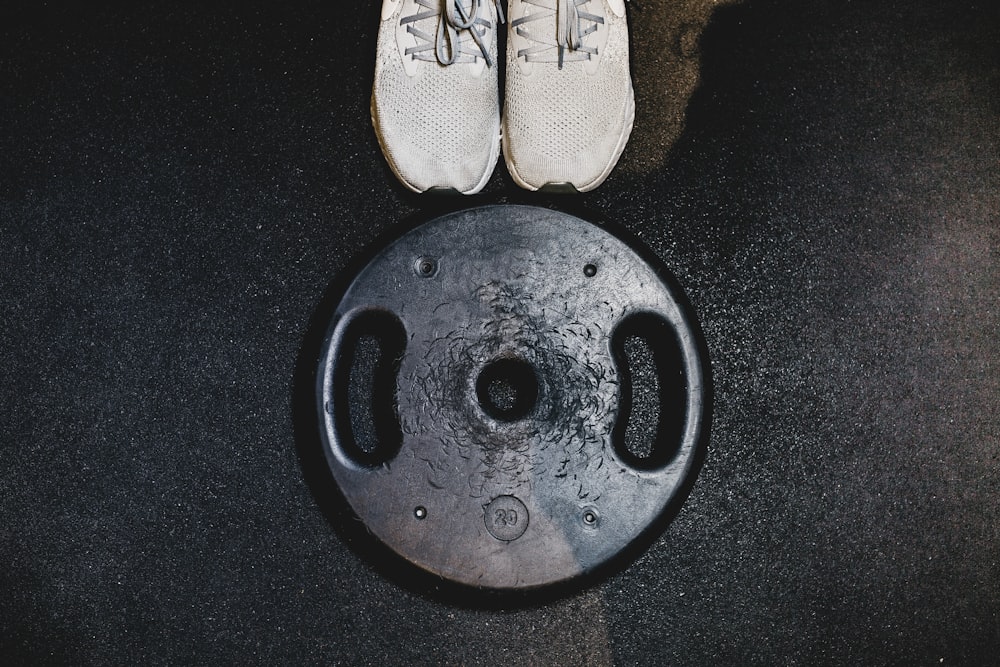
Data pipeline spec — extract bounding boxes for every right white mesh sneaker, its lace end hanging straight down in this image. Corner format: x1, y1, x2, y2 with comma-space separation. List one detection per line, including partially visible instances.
503, 0, 635, 192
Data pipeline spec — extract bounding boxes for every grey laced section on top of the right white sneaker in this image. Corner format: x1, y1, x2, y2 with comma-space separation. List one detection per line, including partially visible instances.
511, 0, 604, 69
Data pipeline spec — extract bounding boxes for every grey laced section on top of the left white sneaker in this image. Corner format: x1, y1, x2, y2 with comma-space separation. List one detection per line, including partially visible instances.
399, 0, 504, 67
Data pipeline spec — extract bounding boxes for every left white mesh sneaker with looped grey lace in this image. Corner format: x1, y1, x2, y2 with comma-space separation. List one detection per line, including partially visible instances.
371, 0, 503, 194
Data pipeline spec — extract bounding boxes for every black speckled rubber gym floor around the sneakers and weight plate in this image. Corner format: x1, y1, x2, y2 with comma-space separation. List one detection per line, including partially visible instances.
0, 0, 1000, 665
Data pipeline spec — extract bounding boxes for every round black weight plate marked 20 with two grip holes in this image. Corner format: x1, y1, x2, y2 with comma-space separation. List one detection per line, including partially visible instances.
318, 206, 708, 589
